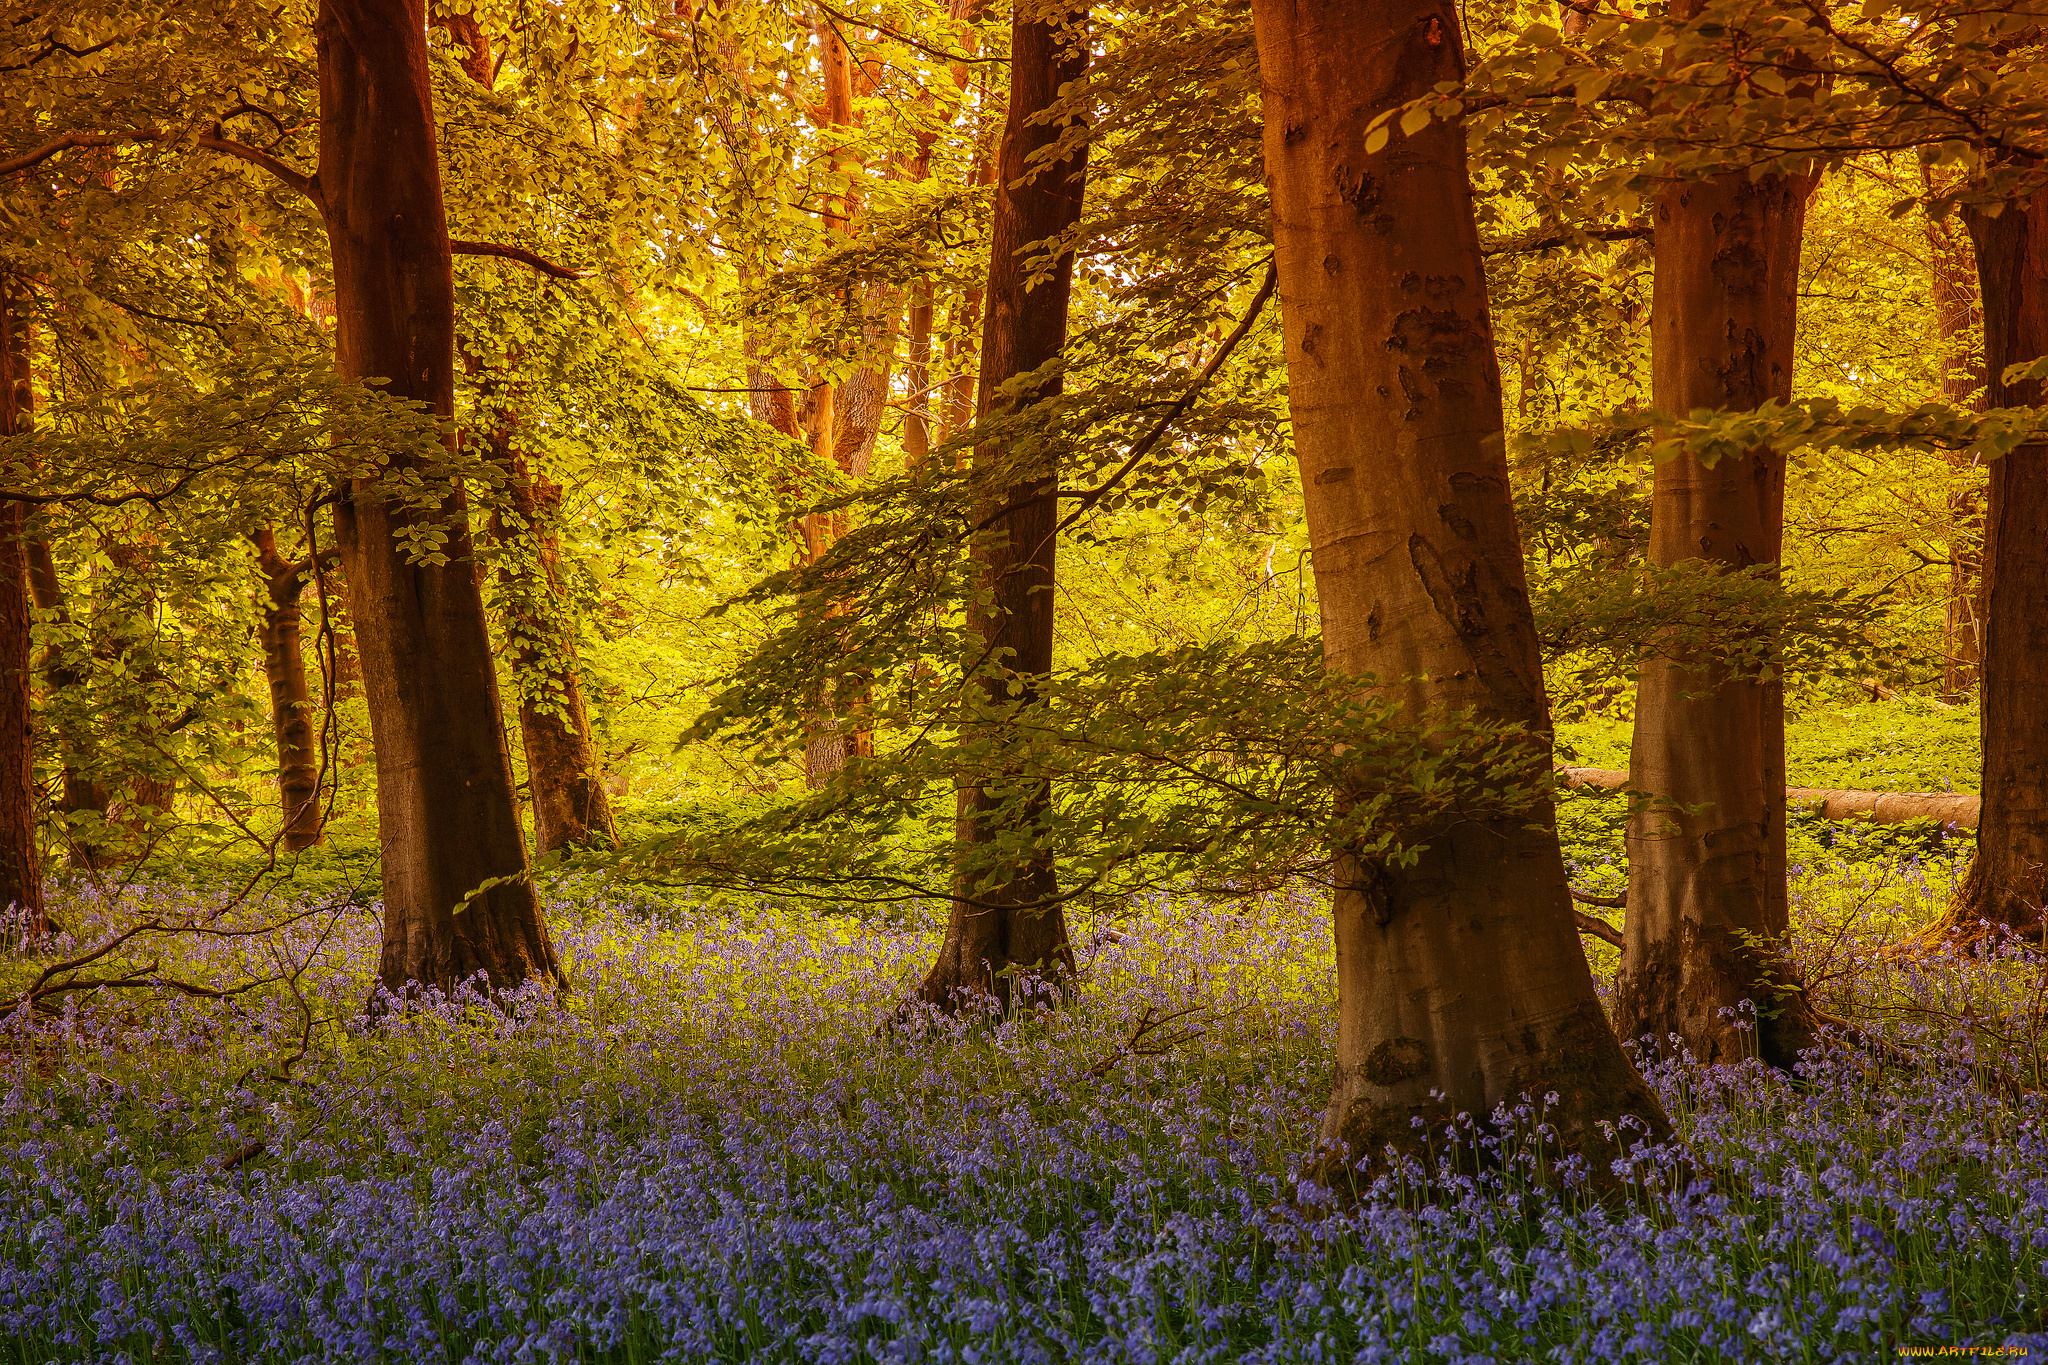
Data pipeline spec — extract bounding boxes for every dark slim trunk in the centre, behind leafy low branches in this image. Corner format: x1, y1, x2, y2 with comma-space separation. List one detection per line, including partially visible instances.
920, 10, 1087, 1007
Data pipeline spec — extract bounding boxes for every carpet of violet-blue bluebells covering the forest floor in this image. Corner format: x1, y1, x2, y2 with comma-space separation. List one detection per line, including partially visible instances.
0, 862, 2048, 1365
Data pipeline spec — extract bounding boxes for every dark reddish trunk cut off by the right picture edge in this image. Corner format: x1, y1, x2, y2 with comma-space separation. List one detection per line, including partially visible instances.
1935, 190, 2048, 933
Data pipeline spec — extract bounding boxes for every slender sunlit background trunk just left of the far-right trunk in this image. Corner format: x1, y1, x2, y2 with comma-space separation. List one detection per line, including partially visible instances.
1927, 201, 1985, 702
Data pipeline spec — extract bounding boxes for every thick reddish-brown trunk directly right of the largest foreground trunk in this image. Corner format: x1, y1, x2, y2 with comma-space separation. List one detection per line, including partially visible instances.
1614, 174, 1815, 1066
